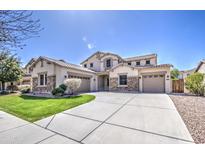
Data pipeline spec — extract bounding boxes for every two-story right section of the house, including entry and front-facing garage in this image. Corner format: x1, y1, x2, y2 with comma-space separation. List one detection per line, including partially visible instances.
81, 52, 172, 93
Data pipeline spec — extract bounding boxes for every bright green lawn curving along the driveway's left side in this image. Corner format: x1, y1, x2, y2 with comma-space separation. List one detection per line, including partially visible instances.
0, 95, 95, 122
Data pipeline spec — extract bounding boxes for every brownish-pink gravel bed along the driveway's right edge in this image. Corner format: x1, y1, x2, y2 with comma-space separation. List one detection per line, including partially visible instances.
169, 94, 205, 143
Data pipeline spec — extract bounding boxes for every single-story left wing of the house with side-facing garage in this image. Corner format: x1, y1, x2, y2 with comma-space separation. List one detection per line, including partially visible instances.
31, 56, 97, 93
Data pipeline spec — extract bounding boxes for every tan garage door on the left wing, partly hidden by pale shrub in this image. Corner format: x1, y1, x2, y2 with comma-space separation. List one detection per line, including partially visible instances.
69, 75, 90, 92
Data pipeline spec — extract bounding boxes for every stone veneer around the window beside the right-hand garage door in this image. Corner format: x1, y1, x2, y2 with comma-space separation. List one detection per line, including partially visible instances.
109, 77, 139, 91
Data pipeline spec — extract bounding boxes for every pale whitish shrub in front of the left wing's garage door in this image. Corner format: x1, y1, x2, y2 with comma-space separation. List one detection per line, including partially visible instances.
64, 78, 81, 94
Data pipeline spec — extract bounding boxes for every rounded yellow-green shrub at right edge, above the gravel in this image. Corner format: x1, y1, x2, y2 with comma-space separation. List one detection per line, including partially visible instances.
185, 73, 205, 96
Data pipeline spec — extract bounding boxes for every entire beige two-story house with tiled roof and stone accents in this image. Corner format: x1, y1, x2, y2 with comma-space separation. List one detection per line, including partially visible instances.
28, 51, 172, 93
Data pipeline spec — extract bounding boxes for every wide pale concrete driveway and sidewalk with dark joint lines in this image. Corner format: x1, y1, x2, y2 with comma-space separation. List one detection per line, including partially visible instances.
0, 92, 193, 144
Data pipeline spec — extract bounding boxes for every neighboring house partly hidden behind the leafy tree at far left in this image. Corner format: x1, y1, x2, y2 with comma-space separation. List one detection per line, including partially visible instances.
0, 58, 36, 91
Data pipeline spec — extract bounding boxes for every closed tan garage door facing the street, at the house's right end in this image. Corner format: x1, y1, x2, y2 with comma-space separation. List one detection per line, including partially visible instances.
142, 74, 165, 93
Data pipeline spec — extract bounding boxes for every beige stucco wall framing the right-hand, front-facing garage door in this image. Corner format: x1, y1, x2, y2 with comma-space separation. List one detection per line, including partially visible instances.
139, 67, 172, 93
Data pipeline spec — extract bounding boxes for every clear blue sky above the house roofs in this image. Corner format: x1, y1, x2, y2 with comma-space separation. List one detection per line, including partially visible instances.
15, 11, 205, 70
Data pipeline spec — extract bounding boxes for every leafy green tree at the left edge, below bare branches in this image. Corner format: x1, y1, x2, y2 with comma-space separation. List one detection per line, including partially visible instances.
0, 51, 23, 90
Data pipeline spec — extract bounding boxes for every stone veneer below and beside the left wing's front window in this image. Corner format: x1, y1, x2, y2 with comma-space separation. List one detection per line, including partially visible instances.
32, 76, 56, 93
